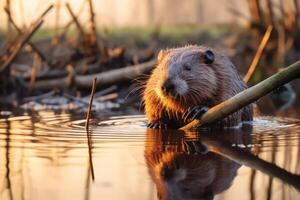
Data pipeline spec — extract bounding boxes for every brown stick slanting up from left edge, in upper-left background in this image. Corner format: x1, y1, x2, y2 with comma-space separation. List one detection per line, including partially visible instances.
0, 20, 44, 72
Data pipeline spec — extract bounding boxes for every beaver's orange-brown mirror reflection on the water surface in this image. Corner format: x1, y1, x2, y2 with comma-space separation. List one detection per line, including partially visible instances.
145, 128, 251, 199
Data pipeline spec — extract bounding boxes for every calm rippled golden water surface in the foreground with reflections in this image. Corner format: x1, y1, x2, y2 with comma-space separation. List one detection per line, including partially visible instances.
0, 111, 300, 200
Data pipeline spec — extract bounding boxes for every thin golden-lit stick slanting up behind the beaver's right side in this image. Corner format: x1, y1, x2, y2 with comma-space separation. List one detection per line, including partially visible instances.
244, 25, 273, 83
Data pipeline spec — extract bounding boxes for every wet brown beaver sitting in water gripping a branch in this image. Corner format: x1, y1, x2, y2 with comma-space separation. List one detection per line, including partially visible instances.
143, 45, 252, 129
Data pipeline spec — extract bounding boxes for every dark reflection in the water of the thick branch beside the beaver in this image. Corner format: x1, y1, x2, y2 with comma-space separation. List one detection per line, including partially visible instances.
201, 137, 300, 191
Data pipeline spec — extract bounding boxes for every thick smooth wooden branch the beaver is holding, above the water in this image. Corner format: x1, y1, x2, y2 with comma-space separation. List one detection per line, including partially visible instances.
181, 60, 300, 129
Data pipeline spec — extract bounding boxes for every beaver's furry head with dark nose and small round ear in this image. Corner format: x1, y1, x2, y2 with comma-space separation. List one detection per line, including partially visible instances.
155, 46, 222, 109
